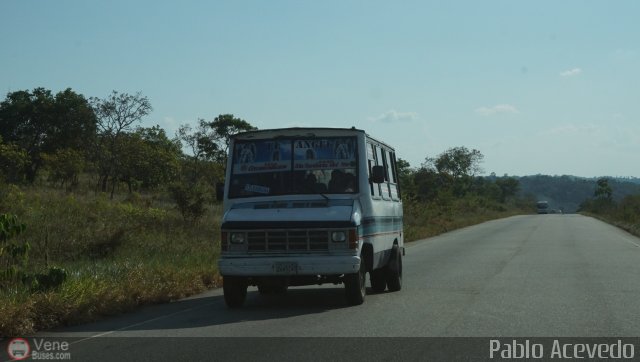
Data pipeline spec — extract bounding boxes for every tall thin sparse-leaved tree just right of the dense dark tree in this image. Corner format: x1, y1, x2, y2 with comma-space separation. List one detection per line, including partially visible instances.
90, 91, 153, 198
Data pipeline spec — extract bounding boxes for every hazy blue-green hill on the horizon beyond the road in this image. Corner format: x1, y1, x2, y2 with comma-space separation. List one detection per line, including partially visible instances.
515, 175, 640, 213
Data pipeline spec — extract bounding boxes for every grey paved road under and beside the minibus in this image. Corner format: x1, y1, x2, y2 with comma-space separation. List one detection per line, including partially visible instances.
16, 215, 640, 358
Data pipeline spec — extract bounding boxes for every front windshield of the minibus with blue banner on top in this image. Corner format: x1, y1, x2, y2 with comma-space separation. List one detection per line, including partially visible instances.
229, 137, 358, 198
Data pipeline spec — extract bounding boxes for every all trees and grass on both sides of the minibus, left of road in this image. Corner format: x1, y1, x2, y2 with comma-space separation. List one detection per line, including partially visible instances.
0, 88, 535, 337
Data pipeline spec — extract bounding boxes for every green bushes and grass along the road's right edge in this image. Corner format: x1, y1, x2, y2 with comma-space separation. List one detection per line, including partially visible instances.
579, 178, 640, 236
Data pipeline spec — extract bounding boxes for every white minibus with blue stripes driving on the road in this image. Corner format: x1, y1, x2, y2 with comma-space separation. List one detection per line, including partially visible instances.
218, 128, 405, 308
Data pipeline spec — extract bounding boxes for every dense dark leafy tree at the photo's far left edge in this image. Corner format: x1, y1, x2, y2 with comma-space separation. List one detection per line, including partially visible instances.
0, 88, 96, 182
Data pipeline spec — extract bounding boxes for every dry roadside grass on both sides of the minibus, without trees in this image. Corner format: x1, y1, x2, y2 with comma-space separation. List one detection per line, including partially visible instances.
0, 185, 527, 337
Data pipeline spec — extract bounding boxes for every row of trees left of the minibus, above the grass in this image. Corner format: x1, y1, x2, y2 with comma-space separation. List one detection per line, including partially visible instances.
0, 88, 255, 215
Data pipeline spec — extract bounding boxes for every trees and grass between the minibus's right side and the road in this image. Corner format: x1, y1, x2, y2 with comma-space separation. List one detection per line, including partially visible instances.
398, 147, 535, 241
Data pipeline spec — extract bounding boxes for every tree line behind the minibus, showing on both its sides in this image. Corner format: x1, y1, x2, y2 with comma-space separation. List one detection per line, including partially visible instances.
0, 88, 519, 217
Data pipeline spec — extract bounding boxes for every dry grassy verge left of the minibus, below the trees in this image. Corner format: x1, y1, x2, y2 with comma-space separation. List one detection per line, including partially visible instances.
0, 186, 220, 336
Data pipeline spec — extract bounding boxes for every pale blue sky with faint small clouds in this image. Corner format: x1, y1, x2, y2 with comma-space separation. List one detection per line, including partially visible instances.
0, 0, 640, 177
